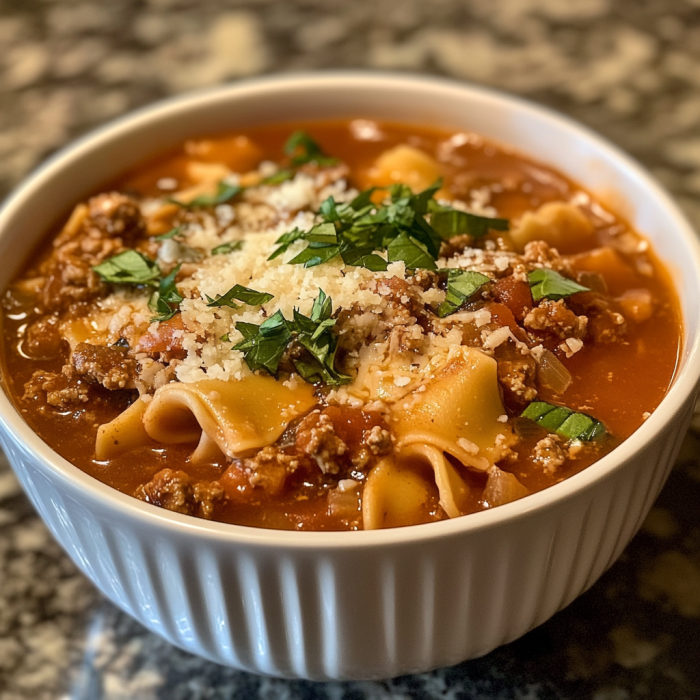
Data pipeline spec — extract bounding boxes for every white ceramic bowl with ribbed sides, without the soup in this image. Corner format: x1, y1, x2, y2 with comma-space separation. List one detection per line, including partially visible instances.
0, 73, 700, 679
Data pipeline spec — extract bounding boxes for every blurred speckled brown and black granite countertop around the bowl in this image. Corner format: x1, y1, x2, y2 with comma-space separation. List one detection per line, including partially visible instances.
0, 0, 700, 700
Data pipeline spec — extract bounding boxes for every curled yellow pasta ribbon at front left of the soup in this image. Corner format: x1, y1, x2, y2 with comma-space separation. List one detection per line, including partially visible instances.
97, 375, 316, 463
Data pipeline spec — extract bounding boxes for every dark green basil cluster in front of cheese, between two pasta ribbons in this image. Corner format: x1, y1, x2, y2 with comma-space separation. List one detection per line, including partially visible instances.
234, 289, 350, 385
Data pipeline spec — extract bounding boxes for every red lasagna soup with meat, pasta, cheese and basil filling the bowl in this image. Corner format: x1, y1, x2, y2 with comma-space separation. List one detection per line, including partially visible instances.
3, 120, 682, 530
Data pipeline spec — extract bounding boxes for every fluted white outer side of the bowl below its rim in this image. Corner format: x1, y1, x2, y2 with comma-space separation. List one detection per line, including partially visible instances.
2, 401, 693, 680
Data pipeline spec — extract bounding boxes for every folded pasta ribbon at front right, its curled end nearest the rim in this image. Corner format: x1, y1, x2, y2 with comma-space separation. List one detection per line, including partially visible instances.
362, 347, 512, 530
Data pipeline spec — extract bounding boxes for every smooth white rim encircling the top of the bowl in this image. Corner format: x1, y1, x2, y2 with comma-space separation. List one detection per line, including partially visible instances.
0, 70, 700, 550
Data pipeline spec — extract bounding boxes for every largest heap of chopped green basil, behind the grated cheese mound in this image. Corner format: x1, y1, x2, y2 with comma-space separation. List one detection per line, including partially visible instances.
269, 181, 508, 271
